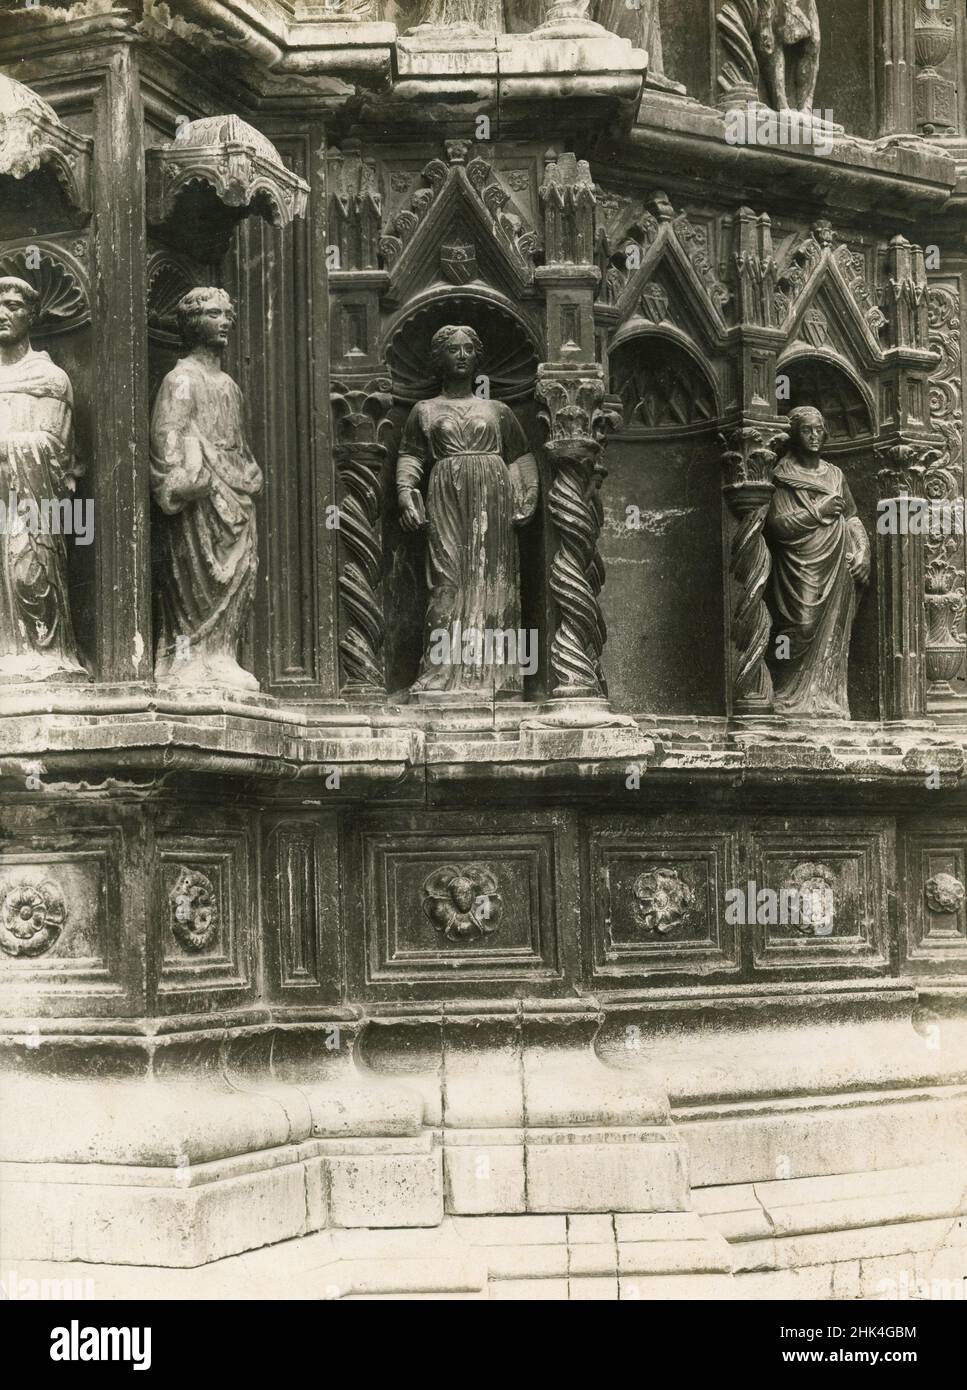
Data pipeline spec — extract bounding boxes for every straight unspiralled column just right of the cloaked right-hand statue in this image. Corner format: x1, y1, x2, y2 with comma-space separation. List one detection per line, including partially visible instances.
877, 445, 927, 719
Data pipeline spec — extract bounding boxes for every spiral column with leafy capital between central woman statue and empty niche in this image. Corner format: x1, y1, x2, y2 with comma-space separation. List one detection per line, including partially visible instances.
536, 366, 617, 698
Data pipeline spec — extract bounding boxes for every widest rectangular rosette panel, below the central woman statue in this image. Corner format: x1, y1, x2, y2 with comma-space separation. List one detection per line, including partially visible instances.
349, 830, 560, 987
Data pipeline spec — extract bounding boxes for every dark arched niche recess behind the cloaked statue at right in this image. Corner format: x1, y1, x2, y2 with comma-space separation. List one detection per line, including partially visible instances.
777, 349, 879, 720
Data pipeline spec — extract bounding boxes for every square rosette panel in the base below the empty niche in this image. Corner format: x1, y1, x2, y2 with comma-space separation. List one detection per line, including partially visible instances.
588, 821, 739, 983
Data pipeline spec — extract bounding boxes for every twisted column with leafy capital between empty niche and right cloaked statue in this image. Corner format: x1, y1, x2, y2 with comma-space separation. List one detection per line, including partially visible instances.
718, 427, 784, 714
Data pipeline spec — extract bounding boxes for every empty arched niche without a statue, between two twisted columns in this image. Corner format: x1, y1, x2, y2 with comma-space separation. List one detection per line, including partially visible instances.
600, 328, 725, 716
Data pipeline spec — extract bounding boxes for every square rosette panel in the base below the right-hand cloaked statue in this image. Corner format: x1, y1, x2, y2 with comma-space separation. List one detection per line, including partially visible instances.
739, 820, 891, 970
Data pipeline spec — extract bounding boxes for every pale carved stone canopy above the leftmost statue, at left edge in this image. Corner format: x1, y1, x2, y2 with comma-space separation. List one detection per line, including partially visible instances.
0, 74, 93, 214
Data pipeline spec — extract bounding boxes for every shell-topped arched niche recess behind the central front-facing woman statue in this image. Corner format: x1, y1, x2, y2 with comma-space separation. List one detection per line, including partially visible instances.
382, 286, 552, 696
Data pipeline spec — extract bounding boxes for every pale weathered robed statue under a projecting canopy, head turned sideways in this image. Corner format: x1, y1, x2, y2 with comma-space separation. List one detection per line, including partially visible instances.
151, 289, 263, 689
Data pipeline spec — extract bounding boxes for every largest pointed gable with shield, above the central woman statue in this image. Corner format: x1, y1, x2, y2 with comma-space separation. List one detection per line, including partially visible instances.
379, 140, 538, 303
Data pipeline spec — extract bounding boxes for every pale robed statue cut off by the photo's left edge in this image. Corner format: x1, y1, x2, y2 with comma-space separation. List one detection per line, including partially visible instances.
0, 277, 88, 682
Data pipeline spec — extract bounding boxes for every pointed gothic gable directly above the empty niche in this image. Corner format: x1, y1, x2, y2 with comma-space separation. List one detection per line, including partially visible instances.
615, 193, 729, 352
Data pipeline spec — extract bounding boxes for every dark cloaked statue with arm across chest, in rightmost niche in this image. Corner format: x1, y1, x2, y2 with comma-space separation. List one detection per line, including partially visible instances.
766, 406, 870, 719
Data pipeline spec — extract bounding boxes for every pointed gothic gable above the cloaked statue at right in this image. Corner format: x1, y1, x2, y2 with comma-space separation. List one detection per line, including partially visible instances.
777, 221, 886, 370
